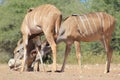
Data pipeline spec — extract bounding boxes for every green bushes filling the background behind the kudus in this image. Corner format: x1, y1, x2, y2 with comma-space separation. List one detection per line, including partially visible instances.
0, 0, 120, 63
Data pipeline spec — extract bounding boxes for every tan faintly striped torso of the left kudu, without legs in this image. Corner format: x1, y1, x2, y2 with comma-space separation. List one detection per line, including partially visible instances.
21, 4, 61, 35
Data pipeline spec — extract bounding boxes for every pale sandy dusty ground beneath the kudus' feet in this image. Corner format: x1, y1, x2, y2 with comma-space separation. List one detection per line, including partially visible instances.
0, 64, 120, 80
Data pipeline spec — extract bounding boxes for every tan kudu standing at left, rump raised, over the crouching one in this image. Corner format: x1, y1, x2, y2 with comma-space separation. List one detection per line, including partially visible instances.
21, 4, 62, 71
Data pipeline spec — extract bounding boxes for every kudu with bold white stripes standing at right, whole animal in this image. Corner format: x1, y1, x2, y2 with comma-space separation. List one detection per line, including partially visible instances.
57, 12, 115, 73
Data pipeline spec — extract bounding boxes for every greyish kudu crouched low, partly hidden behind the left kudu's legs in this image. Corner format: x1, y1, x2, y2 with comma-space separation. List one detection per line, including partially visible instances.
8, 39, 51, 71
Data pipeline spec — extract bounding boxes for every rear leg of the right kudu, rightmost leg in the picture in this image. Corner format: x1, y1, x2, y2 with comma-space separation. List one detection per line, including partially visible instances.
101, 36, 113, 73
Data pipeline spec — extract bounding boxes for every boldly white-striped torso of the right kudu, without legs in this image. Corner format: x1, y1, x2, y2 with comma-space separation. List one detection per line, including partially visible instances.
59, 12, 115, 41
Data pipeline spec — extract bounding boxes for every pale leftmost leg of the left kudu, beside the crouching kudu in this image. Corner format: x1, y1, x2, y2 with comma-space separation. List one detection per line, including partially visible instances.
21, 35, 28, 72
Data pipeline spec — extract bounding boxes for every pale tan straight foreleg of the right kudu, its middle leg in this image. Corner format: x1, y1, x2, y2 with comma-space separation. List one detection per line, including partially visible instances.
74, 41, 82, 72
